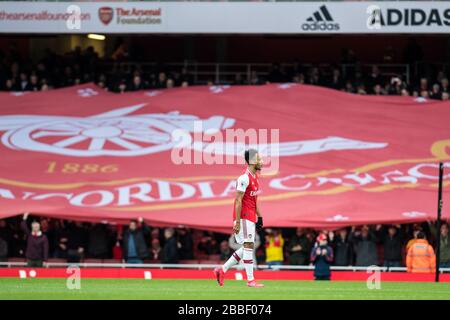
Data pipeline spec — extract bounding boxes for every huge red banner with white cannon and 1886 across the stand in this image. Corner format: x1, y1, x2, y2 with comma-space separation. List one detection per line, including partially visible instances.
0, 84, 450, 231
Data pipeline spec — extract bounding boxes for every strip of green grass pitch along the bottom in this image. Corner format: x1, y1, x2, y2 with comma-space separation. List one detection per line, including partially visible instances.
0, 278, 450, 300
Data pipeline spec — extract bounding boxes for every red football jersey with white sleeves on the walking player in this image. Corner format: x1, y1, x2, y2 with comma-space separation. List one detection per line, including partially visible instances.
233, 169, 259, 222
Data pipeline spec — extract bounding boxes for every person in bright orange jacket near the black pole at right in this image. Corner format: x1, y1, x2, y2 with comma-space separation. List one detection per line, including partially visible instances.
406, 231, 436, 273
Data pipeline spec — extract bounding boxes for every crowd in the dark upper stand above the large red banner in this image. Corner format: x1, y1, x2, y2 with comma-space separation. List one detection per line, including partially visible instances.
0, 42, 450, 100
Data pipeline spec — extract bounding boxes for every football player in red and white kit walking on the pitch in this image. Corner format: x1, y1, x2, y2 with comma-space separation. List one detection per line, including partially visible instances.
214, 149, 264, 288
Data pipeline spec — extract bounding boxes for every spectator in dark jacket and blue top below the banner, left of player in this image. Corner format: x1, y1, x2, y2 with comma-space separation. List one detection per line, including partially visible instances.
123, 217, 150, 263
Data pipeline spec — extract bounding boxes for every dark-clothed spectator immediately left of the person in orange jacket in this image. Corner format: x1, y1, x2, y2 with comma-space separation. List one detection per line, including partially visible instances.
376, 224, 403, 268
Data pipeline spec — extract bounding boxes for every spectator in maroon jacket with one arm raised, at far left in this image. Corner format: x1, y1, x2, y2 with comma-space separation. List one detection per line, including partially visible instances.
21, 213, 48, 268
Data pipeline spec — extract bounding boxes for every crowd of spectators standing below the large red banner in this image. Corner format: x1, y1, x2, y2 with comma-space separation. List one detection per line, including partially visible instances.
0, 214, 450, 270
